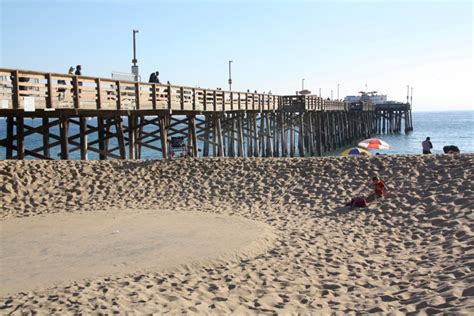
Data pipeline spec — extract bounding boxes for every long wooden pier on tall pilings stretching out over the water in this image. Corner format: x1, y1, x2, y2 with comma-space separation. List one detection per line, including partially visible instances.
0, 68, 413, 160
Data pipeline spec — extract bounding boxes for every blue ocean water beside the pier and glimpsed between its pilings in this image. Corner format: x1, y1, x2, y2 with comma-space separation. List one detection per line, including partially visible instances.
0, 111, 474, 159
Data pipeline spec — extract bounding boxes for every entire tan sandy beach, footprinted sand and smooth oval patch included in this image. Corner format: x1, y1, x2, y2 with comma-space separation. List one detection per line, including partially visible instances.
0, 154, 474, 315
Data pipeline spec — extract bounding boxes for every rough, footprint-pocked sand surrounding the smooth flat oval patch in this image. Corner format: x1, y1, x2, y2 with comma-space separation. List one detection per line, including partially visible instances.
0, 154, 474, 314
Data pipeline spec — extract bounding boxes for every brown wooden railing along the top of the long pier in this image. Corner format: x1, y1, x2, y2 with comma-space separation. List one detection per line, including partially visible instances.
0, 68, 348, 112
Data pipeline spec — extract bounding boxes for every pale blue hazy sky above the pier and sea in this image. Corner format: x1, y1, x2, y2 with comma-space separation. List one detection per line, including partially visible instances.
0, 0, 474, 111
